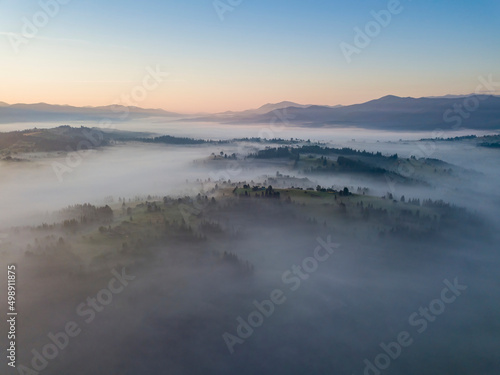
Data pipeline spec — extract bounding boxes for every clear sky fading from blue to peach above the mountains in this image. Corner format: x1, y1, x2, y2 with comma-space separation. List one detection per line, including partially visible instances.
0, 0, 500, 113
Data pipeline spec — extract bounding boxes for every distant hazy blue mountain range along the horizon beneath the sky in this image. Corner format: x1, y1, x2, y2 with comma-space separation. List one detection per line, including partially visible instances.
0, 95, 500, 131
